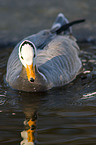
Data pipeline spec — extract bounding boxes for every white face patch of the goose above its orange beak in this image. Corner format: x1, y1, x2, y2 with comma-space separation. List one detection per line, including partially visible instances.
21, 44, 34, 65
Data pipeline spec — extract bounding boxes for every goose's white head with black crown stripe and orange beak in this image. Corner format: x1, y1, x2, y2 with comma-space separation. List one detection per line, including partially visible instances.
19, 40, 36, 82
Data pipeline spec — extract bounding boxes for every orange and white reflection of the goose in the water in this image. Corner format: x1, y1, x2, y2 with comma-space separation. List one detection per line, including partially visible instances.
20, 93, 42, 145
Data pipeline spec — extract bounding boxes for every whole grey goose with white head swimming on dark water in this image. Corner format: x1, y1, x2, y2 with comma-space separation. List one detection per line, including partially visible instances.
6, 13, 84, 92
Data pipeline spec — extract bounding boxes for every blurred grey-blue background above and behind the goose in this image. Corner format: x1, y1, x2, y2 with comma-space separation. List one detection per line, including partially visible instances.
0, 0, 96, 47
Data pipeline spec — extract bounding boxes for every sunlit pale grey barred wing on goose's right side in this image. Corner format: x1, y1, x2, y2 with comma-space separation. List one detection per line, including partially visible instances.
37, 36, 82, 88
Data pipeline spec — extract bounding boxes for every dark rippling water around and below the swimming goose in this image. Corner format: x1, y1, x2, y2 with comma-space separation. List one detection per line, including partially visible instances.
0, 44, 96, 145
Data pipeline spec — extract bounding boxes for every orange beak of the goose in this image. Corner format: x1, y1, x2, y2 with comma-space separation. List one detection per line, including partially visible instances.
26, 63, 35, 81
